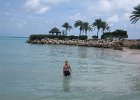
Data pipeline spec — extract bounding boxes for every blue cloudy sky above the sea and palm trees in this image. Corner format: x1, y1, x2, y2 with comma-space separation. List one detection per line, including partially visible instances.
0, 0, 140, 39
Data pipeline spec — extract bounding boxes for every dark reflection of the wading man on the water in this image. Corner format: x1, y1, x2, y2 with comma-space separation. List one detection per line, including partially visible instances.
63, 76, 71, 92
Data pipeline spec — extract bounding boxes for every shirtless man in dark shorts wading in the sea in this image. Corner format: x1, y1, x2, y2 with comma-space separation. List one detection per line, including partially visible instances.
63, 61, 72, 76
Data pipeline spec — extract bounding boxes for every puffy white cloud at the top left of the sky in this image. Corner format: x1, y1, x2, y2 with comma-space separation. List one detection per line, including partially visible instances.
25, 0, 70, 14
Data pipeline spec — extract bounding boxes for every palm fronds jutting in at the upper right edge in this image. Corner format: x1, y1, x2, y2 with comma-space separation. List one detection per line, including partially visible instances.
130, 4, 140, 24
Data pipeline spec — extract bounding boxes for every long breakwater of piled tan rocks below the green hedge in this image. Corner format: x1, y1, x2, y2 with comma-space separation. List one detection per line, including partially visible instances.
27, 38, 123, 50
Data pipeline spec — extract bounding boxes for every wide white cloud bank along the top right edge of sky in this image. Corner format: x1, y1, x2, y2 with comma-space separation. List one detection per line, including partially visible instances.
87, 0, 140, 16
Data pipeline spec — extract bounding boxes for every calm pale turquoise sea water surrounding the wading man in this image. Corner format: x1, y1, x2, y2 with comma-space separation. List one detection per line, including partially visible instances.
0, 38, 140, 100
